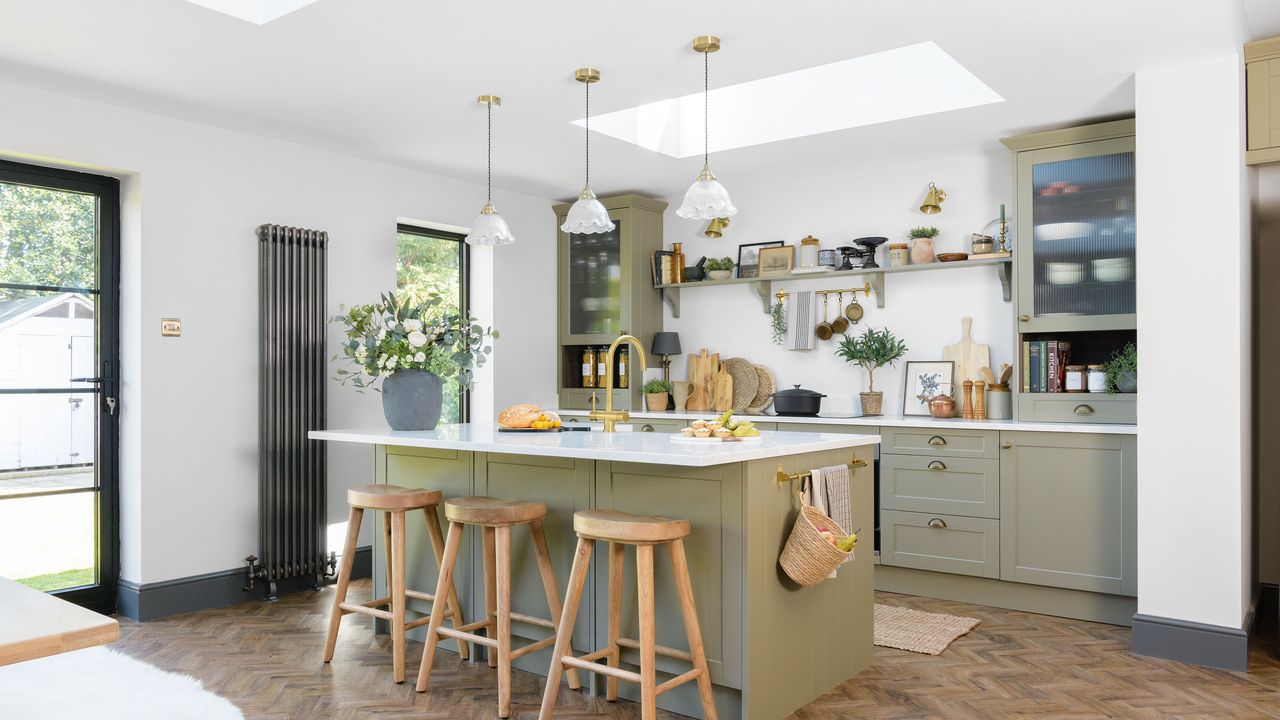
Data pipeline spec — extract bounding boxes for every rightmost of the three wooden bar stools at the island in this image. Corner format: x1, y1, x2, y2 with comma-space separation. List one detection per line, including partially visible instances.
538, 510, 716, 720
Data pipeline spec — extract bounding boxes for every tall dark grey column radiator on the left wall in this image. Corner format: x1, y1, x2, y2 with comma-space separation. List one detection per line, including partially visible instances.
244, 225, 334, 598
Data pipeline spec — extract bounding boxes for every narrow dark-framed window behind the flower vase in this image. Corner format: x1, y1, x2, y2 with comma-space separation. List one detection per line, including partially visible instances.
396, 225, 470, 423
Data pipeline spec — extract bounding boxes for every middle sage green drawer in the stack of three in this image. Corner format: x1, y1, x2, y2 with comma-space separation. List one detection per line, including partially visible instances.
881, 455, 1000, 519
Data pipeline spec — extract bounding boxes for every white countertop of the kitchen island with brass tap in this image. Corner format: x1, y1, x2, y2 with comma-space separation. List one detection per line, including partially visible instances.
307, 424, 881, 468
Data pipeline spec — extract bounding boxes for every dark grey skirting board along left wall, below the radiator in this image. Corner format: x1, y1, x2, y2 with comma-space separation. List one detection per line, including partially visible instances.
115, 547, 372, 620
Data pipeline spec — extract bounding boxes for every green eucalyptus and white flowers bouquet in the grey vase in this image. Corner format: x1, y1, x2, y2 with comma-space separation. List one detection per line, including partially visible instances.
333, 292, 498, 391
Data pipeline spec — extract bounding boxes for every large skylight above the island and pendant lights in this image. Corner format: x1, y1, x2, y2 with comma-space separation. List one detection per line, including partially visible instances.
573, 42, 1005, 158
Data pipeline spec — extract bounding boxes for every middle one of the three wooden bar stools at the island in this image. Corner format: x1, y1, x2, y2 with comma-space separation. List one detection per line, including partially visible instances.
417, 497, 580, 717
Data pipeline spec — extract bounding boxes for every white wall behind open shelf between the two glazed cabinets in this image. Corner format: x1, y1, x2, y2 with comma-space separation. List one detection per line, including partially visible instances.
660, 150, 1014, 415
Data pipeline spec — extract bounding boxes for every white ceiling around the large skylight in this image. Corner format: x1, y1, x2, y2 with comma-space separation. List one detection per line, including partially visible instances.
0, 0, 1249, 199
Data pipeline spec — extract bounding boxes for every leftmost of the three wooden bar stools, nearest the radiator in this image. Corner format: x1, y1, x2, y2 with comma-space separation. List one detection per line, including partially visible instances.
324, 486, 467, 683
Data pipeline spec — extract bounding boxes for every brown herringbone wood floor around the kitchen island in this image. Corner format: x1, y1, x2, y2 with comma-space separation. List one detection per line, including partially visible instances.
113, 580, 1280, 720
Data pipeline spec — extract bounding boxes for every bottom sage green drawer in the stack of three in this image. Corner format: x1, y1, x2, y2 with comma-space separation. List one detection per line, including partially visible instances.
881, 510, 1000, 578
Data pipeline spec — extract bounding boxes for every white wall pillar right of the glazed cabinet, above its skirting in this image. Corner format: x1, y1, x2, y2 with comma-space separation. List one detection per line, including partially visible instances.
1137, 54, 1256, 628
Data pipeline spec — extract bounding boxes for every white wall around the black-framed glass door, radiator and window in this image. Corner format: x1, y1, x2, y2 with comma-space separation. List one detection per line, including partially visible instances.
0, 83, 556, 583
